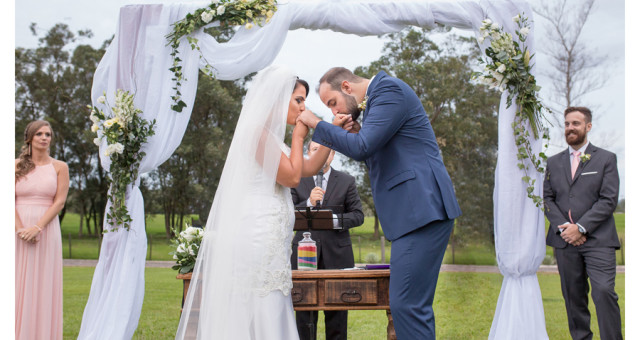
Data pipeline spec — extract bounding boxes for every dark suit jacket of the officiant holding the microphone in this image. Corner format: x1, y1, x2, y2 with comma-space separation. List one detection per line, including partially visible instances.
291, 168, 364, 269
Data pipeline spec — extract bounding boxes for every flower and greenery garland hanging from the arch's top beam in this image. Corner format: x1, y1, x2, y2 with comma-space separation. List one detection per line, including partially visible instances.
167, 0, 277, 112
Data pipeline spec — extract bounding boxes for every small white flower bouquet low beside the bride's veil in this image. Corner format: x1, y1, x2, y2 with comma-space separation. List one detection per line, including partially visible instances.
169, 224, 204, 274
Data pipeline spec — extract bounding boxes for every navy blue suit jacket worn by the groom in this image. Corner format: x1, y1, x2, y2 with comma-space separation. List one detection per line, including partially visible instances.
313, 72, 461, 241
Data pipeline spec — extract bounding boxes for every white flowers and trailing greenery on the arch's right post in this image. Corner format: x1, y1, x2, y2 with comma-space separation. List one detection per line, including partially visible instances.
474, 13, 551, 208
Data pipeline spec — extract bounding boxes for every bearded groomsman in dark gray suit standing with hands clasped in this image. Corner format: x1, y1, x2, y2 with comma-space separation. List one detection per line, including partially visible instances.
544, 107, 622, 340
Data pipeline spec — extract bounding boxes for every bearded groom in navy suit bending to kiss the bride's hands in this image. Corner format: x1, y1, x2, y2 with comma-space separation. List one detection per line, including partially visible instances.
298, 67, 461, 340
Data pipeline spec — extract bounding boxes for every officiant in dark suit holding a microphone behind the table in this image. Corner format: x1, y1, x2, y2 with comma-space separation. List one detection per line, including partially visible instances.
291, 142, 364, 340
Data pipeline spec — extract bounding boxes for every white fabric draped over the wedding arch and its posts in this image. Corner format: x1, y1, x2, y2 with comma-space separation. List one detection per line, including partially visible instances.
79, 0, 548, 339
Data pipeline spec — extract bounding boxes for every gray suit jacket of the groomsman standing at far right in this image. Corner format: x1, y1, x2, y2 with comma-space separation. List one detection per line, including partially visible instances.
544, 143, 620, 249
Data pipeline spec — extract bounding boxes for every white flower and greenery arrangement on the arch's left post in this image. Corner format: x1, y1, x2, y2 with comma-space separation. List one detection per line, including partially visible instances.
89, 89, 156, 231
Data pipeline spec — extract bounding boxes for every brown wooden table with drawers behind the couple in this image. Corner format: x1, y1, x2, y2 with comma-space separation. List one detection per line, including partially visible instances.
176, 269, 396, 340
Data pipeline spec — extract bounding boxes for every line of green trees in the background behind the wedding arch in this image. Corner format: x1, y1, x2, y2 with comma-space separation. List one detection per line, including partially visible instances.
15, 24, 499, 246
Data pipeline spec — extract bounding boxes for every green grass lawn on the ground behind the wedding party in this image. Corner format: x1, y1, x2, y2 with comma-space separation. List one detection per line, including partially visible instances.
64, 267, 625, 340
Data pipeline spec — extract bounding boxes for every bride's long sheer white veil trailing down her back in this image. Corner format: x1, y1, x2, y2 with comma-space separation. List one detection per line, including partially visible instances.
176, 66, 296, 339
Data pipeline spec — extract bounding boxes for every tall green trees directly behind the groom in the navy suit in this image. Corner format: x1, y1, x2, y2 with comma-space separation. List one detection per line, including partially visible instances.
355, 28, 499, 249
